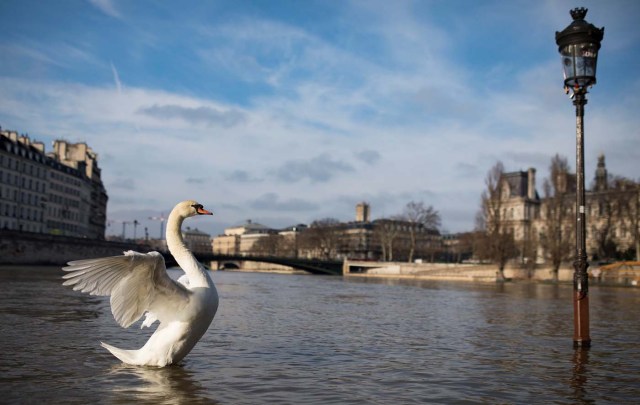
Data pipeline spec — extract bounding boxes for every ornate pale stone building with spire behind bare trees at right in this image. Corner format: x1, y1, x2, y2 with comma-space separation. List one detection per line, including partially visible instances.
501, 155, 640, 263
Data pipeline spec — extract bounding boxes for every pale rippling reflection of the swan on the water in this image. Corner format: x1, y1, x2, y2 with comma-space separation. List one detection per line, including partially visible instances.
107, 363, 218, 404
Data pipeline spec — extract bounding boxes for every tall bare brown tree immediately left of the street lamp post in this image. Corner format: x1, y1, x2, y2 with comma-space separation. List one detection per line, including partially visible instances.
540, 155, 575, 282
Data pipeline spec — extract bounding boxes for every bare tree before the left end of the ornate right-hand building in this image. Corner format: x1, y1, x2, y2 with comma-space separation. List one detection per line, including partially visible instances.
476, 162, 517, 281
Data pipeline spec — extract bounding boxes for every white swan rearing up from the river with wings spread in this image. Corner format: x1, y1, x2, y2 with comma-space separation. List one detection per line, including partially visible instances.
63, 201, 218, 367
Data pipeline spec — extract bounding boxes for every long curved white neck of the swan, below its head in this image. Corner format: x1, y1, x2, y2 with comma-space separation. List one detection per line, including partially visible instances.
167, 210, 209, 288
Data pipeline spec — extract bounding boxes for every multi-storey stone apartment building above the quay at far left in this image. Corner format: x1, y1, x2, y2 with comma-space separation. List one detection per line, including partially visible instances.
0, 130, 108, 239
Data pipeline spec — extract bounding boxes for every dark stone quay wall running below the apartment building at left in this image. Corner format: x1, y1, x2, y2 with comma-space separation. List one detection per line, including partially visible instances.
0, 230, 151, 266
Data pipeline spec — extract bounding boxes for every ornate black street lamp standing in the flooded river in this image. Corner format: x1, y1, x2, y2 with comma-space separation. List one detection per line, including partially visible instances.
556, 7, 604, 347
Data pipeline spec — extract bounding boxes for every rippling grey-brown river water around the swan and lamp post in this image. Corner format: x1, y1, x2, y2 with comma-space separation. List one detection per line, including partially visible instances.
0, 268, 640, 404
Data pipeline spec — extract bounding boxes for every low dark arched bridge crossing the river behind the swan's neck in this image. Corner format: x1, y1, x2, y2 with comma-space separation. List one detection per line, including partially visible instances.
164, 253, 342, 276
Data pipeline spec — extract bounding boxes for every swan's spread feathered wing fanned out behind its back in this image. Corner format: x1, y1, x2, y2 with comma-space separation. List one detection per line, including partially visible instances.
62, 250, 191, 328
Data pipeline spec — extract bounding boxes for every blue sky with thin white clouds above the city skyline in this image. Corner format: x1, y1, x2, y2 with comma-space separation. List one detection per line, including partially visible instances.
0, 0, 640, 237
